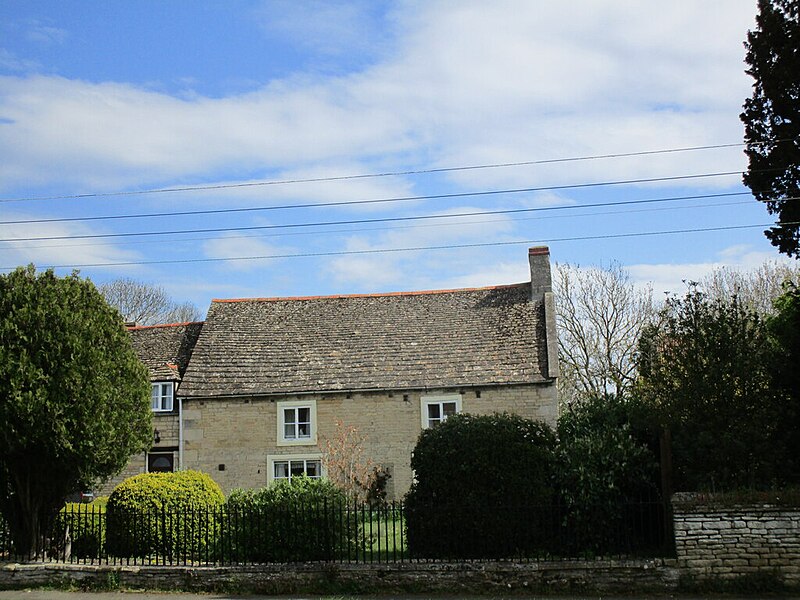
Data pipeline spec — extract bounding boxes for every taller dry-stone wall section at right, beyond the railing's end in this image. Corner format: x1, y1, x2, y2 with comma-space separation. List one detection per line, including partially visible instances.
672, 495, 800, 587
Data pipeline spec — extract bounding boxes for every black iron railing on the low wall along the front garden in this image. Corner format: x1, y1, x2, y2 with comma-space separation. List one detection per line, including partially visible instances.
0, 500, 672, 565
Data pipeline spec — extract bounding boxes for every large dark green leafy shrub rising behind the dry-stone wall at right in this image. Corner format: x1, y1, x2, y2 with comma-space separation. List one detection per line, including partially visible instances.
634, 285, 788, 492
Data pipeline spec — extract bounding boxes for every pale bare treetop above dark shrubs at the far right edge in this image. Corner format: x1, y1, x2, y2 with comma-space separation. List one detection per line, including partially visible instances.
698, 260, 800, 315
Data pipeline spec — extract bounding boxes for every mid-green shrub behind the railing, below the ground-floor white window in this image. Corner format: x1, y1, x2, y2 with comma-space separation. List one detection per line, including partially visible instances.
221, 477, 358, 562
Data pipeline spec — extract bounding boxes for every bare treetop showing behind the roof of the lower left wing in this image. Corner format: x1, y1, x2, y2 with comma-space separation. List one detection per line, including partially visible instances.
99, 278, 202, 325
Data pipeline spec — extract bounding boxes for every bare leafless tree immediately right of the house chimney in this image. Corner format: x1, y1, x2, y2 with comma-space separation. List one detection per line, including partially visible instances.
555, 263, 655, 404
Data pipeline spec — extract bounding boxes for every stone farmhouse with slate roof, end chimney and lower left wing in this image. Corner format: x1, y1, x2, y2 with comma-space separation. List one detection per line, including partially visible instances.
103, 247, 558, 499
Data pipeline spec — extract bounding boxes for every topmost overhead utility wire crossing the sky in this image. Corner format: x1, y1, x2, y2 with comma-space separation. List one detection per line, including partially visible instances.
0, 140, 752, 202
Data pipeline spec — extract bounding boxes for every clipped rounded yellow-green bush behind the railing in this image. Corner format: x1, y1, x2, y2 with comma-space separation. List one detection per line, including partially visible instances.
107, 471, 225, 558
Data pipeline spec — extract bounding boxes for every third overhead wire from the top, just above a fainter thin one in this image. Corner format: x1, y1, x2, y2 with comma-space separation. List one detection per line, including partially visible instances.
0, 192, 749, 242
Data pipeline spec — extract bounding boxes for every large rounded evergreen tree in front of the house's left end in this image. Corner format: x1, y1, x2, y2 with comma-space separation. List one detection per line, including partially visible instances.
0, 266, 152, 555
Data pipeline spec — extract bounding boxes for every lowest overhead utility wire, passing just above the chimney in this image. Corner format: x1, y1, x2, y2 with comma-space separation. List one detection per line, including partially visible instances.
14, 222, 797, 270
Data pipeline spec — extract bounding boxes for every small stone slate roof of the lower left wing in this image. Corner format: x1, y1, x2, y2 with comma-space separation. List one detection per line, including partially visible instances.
128, 323, 203, 381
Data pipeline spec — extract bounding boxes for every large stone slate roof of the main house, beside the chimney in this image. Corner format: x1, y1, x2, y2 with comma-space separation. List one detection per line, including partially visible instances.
179, 283, 547, 398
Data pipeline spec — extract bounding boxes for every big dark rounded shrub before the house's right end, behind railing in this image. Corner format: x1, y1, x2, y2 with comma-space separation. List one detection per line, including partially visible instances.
405, 414, 555, 558
